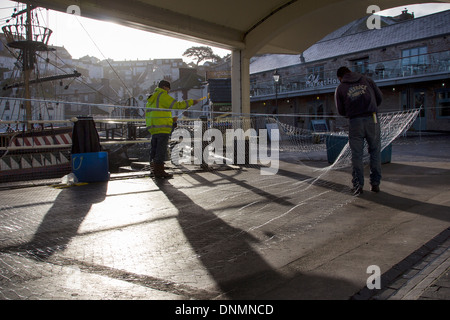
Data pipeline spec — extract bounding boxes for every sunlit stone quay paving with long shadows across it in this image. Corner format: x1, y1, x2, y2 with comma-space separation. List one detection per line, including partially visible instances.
0, 134, 450, 300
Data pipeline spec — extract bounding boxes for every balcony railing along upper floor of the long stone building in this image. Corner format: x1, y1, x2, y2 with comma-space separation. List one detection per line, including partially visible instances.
250, 51, 450, 98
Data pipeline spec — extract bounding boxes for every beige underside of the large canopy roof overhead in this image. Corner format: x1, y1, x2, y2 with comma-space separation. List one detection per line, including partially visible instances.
20, 0, 450, 58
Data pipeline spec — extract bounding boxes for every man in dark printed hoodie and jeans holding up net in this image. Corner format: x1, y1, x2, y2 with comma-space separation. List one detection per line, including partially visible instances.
335, 67, 383, 195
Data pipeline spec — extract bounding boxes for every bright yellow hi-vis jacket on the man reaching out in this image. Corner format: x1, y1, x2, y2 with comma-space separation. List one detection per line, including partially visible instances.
145, 88, 194, 134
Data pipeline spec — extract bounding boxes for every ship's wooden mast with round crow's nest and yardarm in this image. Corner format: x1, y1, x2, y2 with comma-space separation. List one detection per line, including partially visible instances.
2, 3, 81, 129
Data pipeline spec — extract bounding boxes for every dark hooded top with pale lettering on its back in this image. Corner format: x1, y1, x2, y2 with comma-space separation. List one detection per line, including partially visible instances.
334, 72, 383, 119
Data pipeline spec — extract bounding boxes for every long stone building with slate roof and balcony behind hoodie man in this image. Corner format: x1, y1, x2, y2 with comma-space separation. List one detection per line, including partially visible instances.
250, 10, 450, 131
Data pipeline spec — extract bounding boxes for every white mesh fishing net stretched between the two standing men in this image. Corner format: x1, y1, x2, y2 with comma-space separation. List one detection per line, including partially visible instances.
171, 109, 420, 169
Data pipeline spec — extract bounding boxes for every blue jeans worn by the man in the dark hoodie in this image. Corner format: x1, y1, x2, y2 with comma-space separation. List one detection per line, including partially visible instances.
349, 116, 381, 188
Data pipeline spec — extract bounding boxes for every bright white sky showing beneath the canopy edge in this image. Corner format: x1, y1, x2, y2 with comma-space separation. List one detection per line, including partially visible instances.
0, 0, 450, 63
